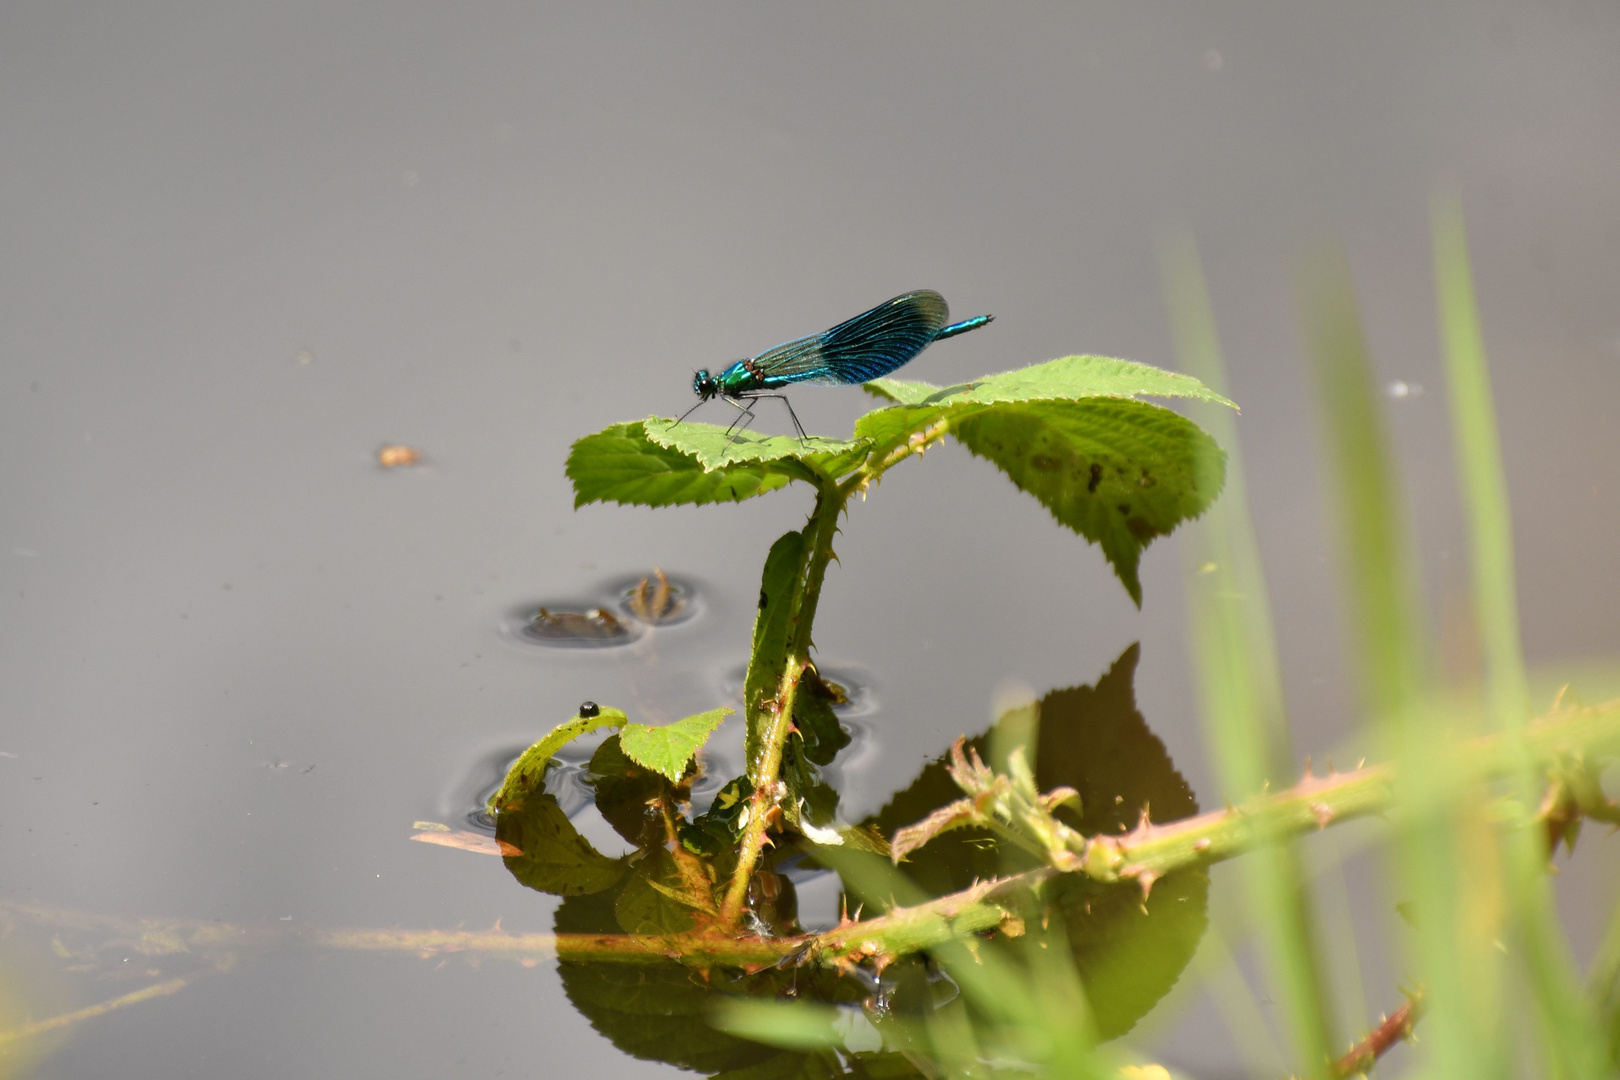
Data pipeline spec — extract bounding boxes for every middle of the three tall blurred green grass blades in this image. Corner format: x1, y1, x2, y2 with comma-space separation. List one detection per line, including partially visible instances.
1296, 243, 1511, 1080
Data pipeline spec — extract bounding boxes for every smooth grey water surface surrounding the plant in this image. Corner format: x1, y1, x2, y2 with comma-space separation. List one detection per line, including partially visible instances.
0, 2, 1620, 1078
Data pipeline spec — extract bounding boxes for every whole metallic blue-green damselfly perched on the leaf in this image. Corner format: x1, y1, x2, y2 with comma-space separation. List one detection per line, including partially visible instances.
676, 288, 995, 445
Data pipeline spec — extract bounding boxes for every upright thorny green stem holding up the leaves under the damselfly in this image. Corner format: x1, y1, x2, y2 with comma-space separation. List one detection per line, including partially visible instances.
719, 476, 849, 926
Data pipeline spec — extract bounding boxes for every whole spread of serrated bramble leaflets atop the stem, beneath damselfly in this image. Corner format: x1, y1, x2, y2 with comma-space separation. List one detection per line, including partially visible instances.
569, 356, 1231, 604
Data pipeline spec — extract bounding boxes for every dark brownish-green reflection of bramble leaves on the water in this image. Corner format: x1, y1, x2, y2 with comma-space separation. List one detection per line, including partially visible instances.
497, 646, 1209, 1077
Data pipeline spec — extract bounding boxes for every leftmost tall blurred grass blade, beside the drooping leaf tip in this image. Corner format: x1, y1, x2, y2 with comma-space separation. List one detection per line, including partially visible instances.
1162, 241, 1337, 1077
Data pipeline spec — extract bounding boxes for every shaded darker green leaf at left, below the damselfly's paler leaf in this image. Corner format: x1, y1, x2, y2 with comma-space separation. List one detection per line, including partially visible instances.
567, 421, 794, 507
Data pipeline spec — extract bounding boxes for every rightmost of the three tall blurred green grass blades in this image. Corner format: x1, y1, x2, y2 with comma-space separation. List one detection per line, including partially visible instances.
1434, 196, 1605, 1077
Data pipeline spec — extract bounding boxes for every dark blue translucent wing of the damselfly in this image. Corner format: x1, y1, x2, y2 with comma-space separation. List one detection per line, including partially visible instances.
753, 290, 951, 387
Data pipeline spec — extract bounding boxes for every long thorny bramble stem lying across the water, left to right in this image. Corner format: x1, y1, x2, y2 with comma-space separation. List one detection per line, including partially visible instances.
0, 701, 1620, 1055
